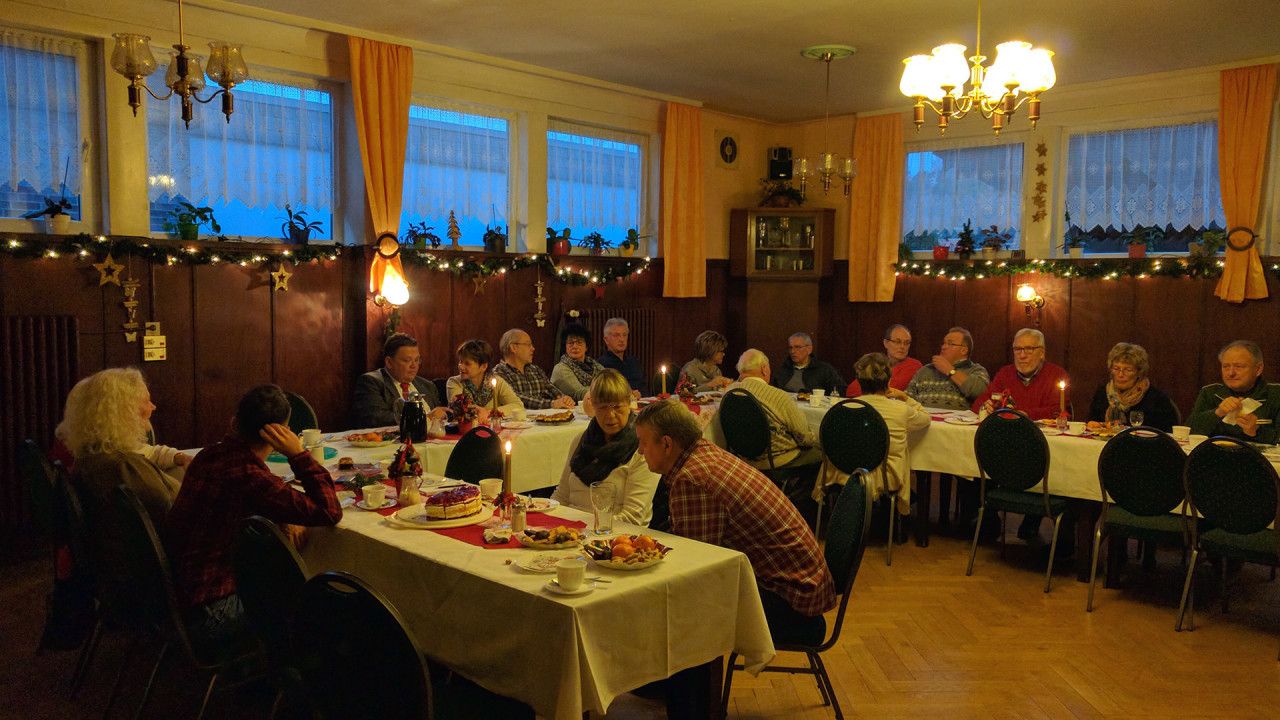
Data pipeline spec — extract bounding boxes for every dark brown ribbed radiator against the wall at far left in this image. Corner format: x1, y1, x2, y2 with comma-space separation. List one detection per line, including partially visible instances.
0, 315, 79, 528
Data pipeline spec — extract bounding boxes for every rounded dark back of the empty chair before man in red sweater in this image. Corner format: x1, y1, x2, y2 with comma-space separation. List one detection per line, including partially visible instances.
973, 407, 1048, 492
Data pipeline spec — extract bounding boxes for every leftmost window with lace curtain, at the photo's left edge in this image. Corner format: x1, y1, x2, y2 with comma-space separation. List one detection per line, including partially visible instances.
0, 31, 86, 220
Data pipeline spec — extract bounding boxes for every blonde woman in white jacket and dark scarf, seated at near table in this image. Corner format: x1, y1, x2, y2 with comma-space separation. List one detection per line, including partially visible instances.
552, 370, 658, 527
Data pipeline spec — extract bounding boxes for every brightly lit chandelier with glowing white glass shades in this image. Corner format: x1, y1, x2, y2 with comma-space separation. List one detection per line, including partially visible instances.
899, 0, 1057, 135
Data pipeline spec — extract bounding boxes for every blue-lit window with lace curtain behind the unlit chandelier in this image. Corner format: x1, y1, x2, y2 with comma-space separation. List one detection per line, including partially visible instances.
147, 68, 334, 238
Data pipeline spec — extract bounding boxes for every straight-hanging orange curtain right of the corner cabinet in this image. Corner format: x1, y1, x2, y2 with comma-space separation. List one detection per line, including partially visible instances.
849, 113, 905, 302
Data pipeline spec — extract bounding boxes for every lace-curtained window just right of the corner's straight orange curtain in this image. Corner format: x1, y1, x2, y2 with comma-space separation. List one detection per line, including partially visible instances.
902, 142, 1023, 250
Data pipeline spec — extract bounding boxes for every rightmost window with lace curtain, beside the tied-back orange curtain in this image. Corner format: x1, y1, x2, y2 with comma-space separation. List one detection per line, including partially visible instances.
1066, 122, 1226, 252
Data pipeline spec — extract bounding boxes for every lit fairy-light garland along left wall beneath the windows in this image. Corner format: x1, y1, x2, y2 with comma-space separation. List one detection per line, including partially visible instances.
0, 233, 652, 286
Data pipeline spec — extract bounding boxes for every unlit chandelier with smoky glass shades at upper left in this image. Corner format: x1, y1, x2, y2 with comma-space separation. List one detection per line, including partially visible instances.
111, 0, 248, 128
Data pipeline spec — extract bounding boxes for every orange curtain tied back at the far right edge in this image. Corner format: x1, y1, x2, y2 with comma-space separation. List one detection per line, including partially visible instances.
1213, 65, 1276, 302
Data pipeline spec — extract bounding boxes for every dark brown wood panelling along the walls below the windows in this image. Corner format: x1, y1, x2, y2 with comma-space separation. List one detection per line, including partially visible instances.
0, 243, 1280, 447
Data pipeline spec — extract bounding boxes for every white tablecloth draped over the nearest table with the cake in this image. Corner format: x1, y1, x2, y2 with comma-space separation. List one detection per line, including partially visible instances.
302, 507, 774, 720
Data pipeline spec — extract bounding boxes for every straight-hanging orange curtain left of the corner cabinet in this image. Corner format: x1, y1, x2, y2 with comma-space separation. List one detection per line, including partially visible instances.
662, 102, 707, 297
